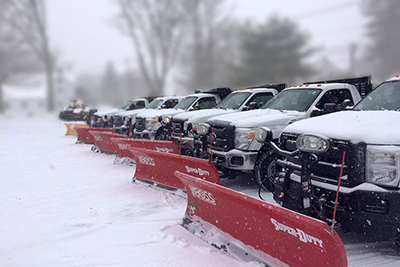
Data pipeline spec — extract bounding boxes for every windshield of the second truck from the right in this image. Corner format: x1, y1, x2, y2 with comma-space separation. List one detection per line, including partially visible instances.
262, 88, 322, 111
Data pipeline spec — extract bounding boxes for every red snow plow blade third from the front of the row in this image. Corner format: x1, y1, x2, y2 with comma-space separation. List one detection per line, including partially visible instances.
111, 137, 179, 163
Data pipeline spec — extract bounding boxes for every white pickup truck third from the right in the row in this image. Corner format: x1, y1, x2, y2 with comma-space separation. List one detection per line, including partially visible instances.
171, 84, 286, 157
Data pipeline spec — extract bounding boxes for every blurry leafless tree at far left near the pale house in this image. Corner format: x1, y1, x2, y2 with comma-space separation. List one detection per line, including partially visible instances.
1, 0, 55, 111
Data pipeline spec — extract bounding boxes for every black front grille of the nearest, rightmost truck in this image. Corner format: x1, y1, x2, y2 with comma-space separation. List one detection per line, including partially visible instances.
281, 133, 366, 187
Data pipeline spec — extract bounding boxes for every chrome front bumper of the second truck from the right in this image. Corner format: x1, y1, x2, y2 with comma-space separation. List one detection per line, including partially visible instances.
208, 149, 258, 171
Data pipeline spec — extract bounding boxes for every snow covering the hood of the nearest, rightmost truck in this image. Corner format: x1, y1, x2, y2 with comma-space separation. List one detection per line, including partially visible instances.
284, 110, 400, 145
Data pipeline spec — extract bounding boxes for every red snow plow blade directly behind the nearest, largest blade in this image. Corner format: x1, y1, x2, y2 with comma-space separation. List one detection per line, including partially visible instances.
128, 147, 220, 191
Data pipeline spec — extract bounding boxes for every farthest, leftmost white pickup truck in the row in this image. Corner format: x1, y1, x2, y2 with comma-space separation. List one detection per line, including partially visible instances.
91, 97, 155, 128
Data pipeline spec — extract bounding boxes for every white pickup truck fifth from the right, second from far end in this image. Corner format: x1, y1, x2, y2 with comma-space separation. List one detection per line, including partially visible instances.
112, 96, 183, 134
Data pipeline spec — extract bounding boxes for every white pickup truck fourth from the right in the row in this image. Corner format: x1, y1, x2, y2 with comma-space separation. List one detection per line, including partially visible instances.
133, 87, 232, 140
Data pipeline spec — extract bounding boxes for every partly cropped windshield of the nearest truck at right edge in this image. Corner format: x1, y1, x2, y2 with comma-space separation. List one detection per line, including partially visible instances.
354, 81, 400, 110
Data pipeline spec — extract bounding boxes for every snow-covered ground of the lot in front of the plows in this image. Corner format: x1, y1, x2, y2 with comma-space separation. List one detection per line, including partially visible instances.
0, 115, 400, 267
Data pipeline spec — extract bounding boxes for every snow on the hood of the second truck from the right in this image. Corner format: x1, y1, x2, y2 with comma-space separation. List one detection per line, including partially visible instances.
208, 109, 305, 128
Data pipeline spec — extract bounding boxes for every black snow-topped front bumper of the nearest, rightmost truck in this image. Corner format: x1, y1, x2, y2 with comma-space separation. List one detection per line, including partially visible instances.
291, 174, 400, 234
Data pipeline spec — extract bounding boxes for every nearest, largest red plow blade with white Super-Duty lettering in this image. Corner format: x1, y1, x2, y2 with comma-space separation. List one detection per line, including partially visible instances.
175, 172, 347, 267
